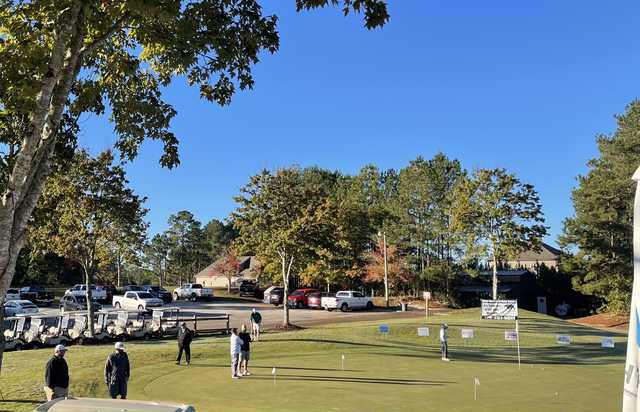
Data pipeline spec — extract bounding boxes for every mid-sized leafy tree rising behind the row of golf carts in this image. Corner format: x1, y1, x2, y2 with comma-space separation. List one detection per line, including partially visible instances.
29, 151, 147, 336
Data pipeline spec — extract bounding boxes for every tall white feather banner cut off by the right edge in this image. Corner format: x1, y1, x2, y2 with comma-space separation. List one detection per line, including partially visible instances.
622, 167, 640, 412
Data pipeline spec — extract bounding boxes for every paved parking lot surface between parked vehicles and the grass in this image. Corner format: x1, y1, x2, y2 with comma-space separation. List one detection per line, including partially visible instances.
40, 297, 424, 329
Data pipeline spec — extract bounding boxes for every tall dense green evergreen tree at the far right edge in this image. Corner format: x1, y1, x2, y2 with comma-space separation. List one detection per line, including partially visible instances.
560, 100, 640, 312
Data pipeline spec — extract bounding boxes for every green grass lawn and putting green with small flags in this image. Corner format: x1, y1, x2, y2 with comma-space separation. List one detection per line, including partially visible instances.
0, 309, 626, 412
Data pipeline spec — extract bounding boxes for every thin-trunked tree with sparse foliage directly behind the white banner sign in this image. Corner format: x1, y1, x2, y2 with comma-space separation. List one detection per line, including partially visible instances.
452, 169, 547, 299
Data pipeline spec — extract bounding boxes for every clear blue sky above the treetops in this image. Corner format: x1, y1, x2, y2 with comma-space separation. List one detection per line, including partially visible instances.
80, 0, 640, 242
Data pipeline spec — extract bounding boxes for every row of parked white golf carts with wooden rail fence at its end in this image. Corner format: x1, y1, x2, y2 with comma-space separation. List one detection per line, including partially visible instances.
3, 307, 229, 350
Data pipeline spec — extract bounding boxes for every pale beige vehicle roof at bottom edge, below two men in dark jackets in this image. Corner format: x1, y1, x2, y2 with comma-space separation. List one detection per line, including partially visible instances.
34, 398, 196, 412
